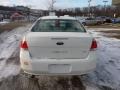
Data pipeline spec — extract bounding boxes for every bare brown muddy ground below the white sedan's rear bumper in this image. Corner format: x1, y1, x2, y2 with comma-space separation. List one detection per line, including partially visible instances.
0, 75, 86, 90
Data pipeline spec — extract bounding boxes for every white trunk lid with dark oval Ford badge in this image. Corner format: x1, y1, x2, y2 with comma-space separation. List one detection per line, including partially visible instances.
26, 32, 93, 59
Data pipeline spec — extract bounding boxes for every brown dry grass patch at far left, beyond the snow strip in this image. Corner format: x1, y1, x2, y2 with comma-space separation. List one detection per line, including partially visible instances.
0, 22, 27, 33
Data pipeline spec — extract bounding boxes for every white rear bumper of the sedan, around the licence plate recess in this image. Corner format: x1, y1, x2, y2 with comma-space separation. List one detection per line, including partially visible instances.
20, 51, 96, 75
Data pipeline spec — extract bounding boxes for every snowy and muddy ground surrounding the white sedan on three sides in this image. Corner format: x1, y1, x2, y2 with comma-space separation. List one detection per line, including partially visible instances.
0, 25, 120, 90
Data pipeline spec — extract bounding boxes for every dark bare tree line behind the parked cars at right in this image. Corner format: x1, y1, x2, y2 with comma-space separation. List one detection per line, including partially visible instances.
55, 5, 120, 17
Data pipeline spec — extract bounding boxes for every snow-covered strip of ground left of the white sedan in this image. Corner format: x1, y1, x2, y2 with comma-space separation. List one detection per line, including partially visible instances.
0, 25, 30, 81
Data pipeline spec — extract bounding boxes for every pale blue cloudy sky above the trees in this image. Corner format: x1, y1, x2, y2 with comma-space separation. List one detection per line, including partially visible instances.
0, 0, 112, 9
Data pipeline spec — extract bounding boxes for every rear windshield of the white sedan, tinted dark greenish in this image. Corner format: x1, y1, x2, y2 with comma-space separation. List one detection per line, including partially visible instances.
31, 19, 86, 32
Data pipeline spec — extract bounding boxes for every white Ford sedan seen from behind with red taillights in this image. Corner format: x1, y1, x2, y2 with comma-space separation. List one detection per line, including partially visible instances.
20, 16, 97, 75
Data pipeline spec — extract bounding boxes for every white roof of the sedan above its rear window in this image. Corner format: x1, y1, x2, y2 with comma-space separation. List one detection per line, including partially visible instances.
38, 15, 77, 20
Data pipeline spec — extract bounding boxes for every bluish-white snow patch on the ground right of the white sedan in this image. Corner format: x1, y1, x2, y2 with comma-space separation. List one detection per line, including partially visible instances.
82, 29, 120, 90
